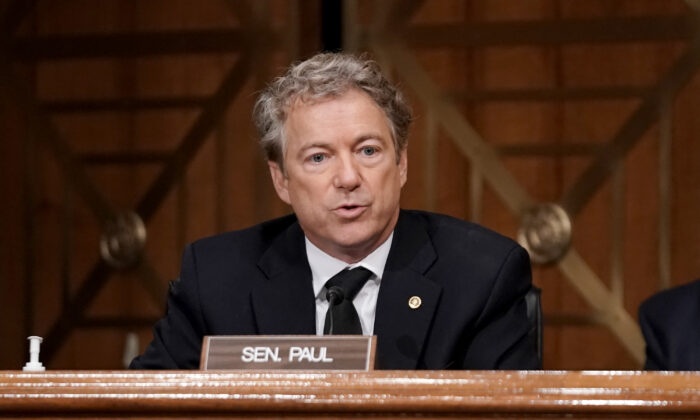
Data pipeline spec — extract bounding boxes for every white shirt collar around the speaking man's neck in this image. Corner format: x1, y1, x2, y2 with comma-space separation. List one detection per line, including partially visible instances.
304, 232, 394, 298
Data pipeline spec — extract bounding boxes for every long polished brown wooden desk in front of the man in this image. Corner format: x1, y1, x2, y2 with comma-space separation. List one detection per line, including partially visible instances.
0, 371, 700, 419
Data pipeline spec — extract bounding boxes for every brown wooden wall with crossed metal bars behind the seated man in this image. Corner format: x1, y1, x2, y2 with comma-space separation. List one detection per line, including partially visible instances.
0, 0, 700, 369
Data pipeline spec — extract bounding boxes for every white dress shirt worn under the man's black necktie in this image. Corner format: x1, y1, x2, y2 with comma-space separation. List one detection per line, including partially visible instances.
305, 232, 394, 335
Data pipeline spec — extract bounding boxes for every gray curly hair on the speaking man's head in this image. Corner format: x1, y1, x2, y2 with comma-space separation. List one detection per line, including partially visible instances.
253, 53, 413, 168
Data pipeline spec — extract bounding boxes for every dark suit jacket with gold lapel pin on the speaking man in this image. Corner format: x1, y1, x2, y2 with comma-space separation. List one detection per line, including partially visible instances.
130, 211, 538, 369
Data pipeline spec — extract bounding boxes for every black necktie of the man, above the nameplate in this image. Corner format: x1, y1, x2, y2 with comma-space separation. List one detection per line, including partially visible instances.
323, 267, 372, 334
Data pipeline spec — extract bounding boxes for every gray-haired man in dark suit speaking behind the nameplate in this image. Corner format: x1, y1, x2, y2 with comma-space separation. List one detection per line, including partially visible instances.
131, 54, 538, 369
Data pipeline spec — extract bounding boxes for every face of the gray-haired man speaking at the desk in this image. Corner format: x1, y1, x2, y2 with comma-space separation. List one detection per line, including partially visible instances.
269, 90, 407, 262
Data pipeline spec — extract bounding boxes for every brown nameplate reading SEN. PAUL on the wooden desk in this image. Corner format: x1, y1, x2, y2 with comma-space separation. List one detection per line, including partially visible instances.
199, 335, 376, 371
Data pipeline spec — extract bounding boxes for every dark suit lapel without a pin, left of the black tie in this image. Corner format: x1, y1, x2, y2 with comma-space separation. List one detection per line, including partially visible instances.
251, 222, 316, 335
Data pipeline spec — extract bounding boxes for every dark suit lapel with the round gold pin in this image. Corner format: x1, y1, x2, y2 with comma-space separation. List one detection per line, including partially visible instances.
374, 211, 442, 369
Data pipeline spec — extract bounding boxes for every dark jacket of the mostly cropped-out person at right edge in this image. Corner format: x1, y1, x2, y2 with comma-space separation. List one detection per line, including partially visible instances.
639, 279, 700, 370
